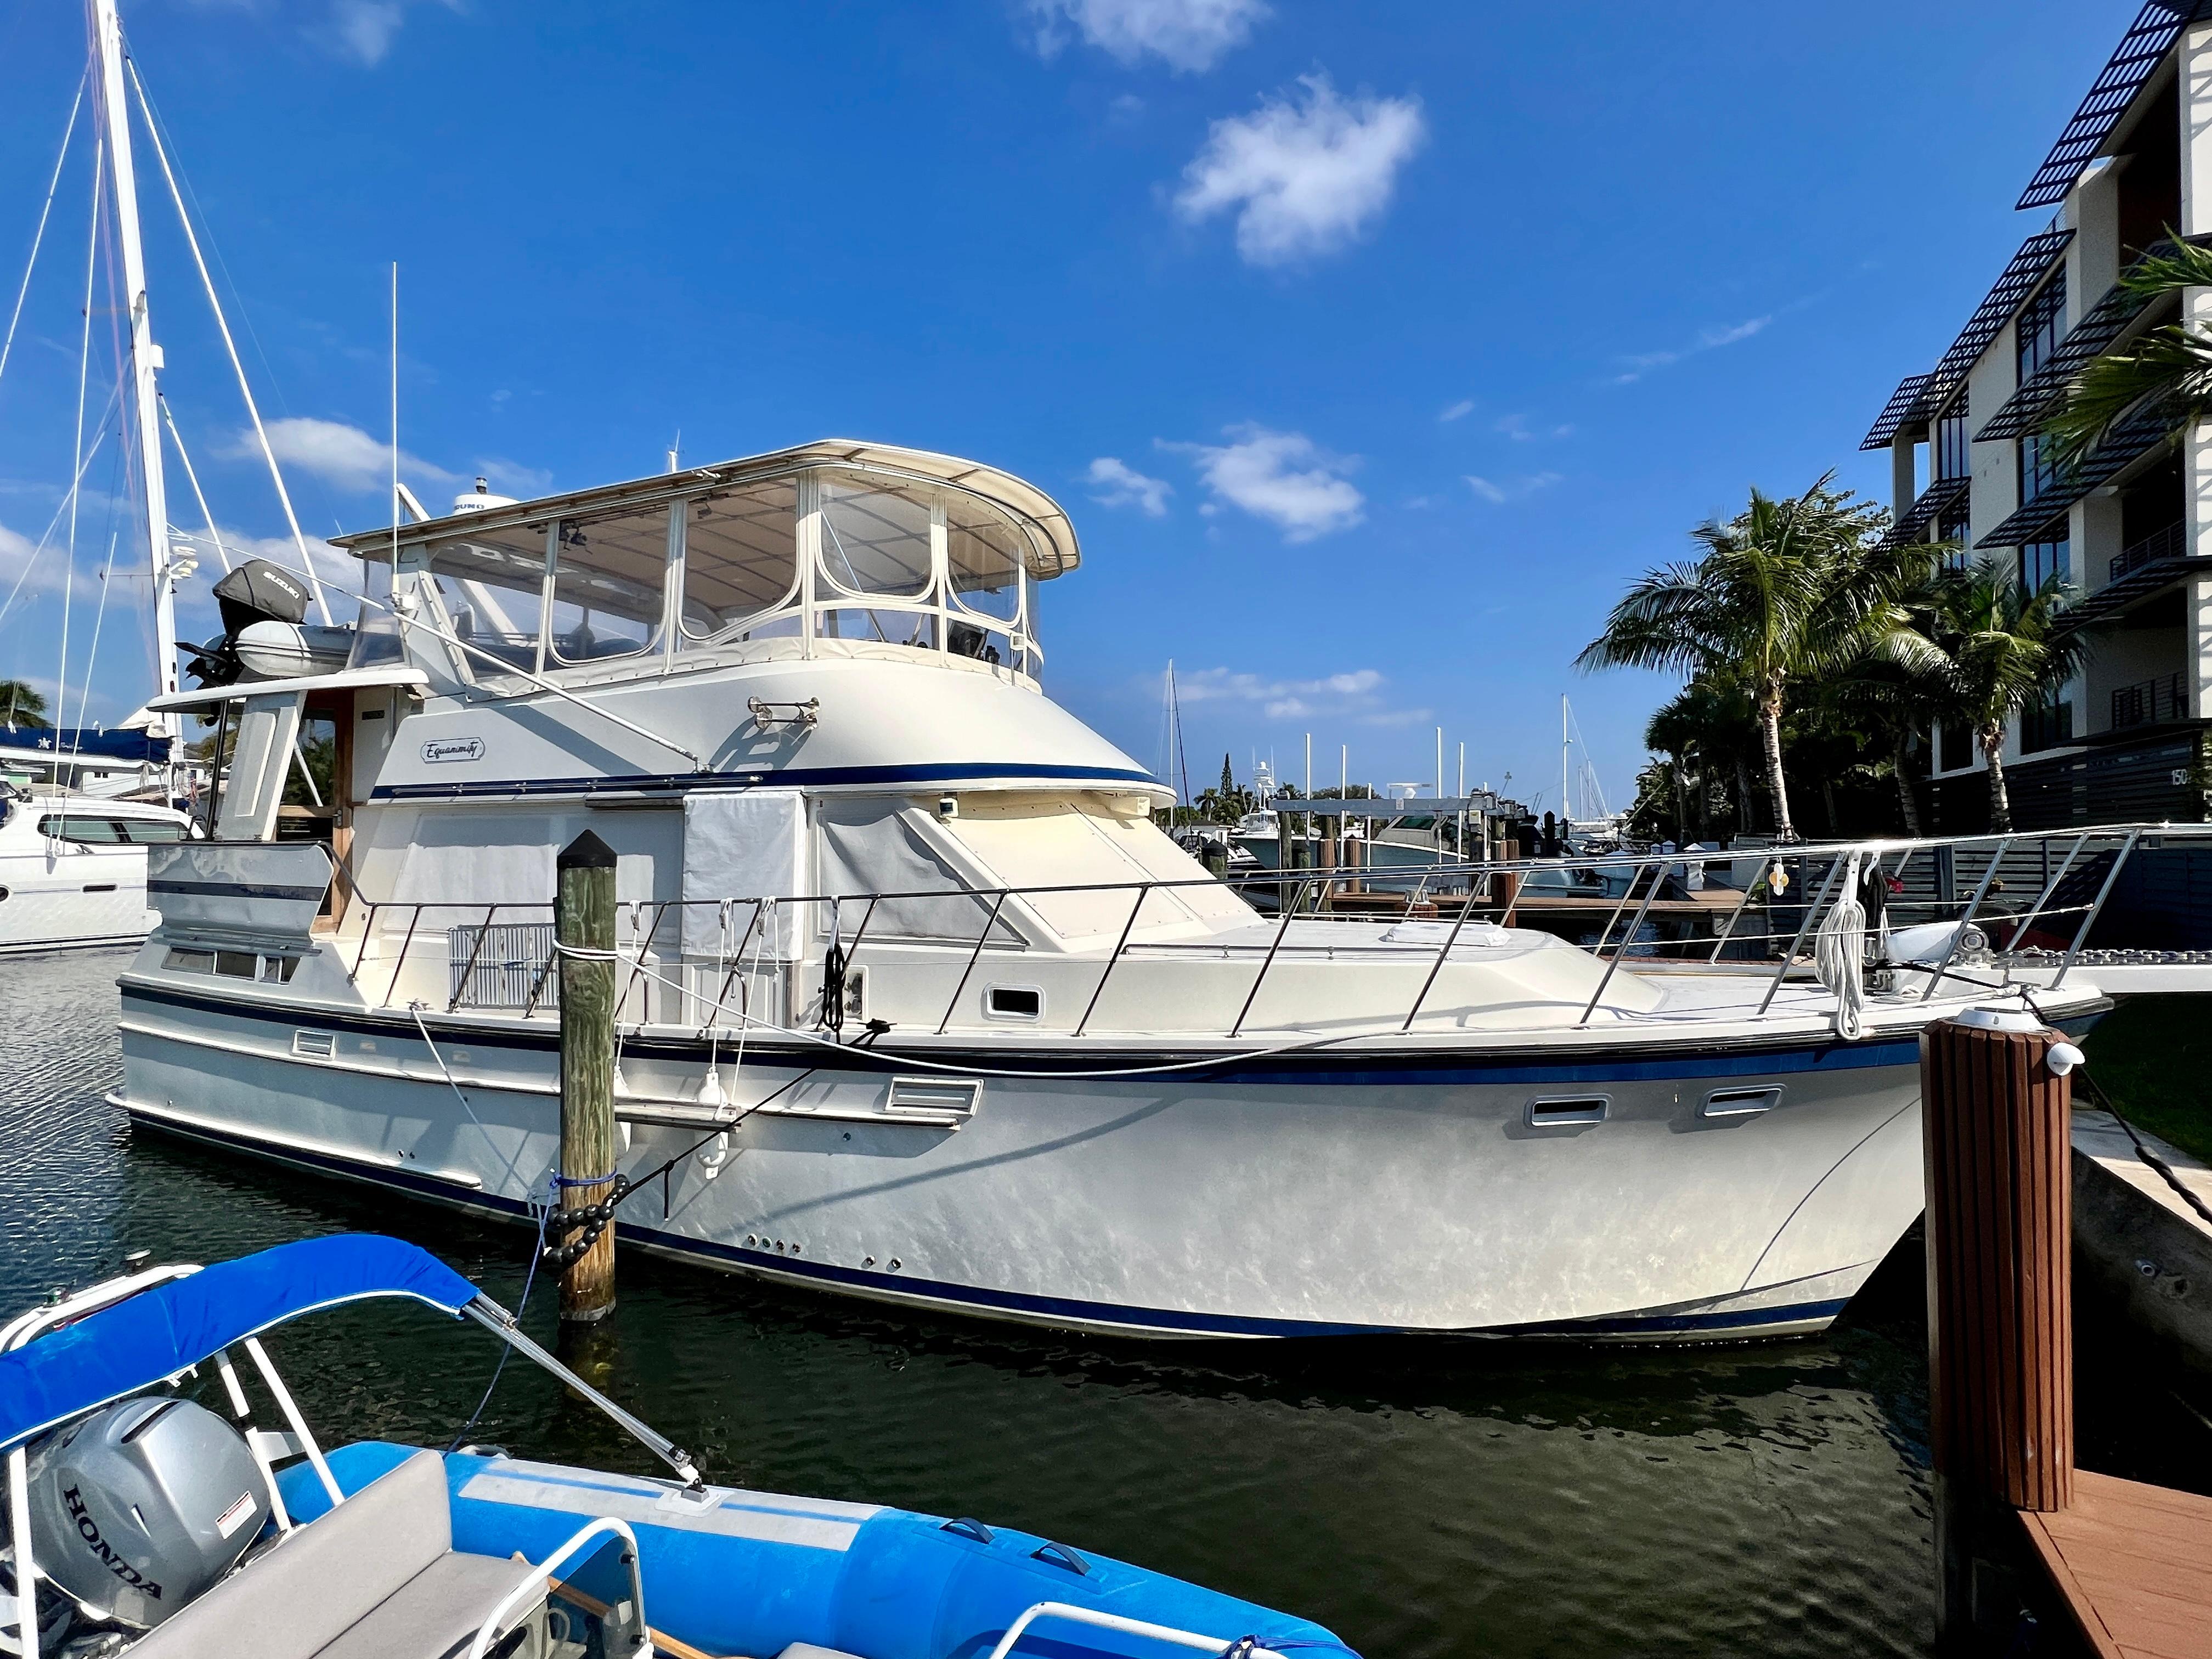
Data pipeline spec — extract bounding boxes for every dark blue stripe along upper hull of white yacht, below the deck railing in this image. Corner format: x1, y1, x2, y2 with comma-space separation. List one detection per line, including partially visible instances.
122, 980, 1920, 1088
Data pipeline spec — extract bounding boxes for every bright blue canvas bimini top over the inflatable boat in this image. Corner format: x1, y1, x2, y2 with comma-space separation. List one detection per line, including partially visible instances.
0, 1232, 476, 1451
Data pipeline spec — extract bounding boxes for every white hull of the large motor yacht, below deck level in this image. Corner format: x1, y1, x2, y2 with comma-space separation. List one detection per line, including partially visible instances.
115, 978, 1920, 1340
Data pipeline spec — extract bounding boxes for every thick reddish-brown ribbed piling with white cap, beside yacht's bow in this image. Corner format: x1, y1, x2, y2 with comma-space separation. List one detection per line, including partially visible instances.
1920, 1009, 2079, 1644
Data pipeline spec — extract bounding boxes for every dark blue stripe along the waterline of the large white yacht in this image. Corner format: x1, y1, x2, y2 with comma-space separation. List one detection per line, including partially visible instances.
109, 1095, 1845, 1338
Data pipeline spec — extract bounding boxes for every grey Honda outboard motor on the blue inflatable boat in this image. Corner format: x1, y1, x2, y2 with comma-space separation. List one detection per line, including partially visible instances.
31, 1396, 270, 1630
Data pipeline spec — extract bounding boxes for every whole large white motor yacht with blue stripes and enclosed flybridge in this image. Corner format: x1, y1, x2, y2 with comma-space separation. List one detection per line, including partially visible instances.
117, 442, 2132, 1338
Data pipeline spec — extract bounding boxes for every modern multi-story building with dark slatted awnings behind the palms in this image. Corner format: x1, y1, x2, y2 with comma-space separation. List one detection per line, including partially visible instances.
1863, 0, 2212, 834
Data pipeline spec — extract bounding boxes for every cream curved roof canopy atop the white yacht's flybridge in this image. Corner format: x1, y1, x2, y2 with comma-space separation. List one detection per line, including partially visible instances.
330, 438, 1082, 582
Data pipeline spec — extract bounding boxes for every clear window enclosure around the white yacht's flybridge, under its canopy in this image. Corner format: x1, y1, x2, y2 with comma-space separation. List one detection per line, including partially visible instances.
358, 467, 1053, 679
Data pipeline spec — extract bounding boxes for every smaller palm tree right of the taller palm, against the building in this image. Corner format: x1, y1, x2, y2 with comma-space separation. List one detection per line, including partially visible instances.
1933, 557, 2088, 834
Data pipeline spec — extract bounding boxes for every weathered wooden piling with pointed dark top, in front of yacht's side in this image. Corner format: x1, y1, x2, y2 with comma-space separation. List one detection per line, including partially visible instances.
553, 830, 615, 1323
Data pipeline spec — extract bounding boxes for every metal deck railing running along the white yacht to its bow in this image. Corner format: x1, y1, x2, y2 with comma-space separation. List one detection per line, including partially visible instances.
316, 825, 2212, 1040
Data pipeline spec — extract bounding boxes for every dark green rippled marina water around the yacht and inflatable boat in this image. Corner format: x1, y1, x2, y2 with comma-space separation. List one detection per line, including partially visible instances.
0, 956, 2212, 1659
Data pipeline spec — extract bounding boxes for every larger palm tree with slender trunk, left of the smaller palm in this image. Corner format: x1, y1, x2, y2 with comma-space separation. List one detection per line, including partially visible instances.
1575, 473, 1942, 840
